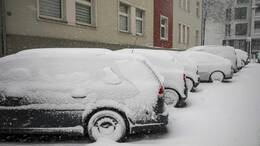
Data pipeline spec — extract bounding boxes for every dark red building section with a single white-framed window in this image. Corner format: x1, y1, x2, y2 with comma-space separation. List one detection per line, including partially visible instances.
154, 0, 173, 48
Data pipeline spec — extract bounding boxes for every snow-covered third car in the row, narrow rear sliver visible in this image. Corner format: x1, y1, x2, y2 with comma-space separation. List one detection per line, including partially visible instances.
168, 51, 200, 92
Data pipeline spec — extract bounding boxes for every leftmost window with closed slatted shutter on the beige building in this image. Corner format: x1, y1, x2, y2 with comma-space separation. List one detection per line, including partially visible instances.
39, 0, 63, 20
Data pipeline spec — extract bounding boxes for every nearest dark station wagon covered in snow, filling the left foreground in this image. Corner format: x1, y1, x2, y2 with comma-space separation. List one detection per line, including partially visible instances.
0, 49, 168, 141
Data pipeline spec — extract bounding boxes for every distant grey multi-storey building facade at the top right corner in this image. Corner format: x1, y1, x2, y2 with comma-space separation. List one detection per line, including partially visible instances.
223, 0, 260, 52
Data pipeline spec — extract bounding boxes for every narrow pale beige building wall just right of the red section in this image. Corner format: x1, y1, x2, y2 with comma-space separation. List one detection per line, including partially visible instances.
173, 0, 202, 49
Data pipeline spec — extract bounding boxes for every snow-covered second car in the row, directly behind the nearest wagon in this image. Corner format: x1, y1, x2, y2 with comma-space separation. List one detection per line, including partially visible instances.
117, 49, 188, 107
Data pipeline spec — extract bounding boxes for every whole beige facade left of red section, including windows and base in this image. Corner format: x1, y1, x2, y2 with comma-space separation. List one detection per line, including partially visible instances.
2, 0, 154, 54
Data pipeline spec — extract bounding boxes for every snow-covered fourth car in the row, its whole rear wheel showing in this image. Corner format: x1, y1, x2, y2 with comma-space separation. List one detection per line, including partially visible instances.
182, 51, 233, 82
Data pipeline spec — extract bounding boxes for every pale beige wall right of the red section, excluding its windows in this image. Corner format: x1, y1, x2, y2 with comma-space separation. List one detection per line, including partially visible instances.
173, 0, 202, 49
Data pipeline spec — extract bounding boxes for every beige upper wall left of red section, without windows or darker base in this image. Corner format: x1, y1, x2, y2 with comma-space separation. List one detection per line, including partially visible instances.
7, 0, 154, 51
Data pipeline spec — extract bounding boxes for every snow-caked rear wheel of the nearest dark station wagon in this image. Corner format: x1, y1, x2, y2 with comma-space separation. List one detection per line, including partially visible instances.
87, 110, 126, 141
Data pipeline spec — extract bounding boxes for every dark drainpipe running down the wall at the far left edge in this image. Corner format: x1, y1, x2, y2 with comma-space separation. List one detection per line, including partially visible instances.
1, 0, 6, 56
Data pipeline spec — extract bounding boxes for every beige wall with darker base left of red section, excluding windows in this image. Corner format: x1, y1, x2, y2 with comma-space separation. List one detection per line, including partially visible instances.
7, 0, 154, 53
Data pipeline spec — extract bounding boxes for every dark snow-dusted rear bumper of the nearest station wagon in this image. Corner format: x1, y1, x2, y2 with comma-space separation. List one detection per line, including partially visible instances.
130, 113, 168, 134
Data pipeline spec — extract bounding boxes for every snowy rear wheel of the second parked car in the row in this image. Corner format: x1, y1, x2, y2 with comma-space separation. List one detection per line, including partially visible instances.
164, 89, 180, 107
